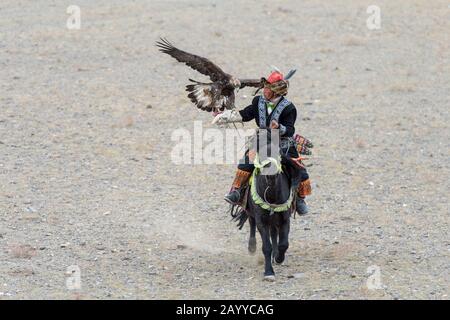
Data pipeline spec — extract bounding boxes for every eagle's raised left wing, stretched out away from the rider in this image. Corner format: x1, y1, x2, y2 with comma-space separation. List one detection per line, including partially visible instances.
156, 38, 230, 82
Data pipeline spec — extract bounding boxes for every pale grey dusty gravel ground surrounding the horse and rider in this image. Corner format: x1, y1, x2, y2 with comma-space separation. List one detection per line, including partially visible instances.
0, 0, 450, 299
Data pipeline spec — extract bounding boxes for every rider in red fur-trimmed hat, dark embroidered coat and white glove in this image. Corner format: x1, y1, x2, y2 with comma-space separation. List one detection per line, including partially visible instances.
214, 71, 311, 214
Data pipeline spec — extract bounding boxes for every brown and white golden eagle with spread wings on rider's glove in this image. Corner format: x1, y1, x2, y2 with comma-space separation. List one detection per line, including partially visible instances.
156, 38, 266, 112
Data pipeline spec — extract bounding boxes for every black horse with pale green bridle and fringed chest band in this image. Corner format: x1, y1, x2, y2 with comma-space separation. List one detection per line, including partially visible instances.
234, 130, 296, 281
